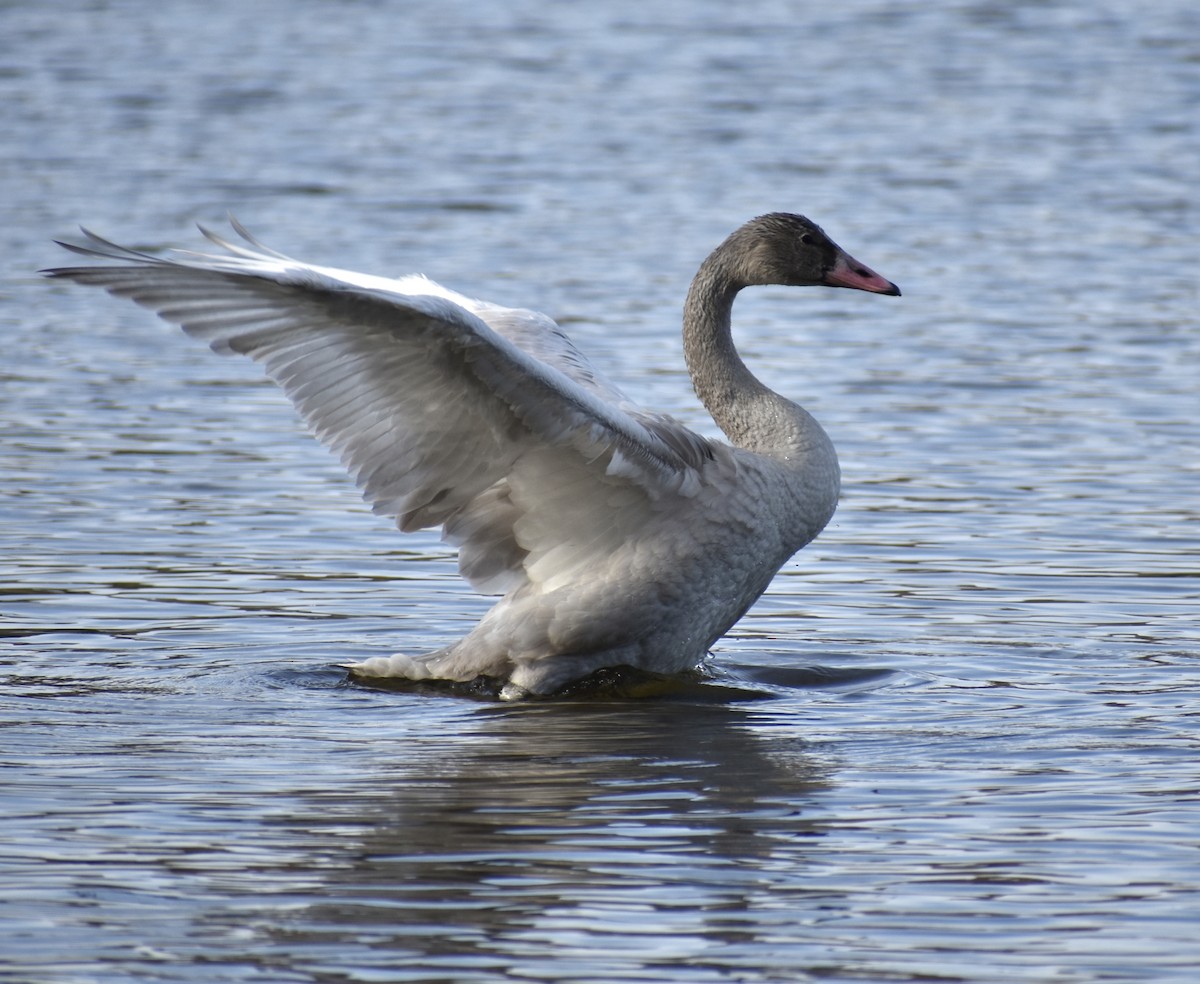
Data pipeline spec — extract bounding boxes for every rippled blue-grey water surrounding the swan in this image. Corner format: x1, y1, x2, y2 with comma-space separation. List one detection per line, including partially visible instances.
0, 0, 1200, 984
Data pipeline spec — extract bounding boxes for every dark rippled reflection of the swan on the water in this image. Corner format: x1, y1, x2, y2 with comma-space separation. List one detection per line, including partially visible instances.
260, 701, 828, 967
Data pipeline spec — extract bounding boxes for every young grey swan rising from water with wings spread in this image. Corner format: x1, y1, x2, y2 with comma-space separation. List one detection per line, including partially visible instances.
43, 212, 900, 700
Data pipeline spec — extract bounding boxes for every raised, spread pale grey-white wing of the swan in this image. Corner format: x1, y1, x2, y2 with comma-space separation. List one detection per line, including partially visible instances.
44, 223, 719, 590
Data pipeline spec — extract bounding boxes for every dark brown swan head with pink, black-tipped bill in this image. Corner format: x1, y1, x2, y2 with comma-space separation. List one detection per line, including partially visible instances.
718, 212, 900, 296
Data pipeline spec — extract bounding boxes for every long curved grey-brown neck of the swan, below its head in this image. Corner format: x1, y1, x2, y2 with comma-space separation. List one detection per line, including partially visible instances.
683, 250, 833, 458
